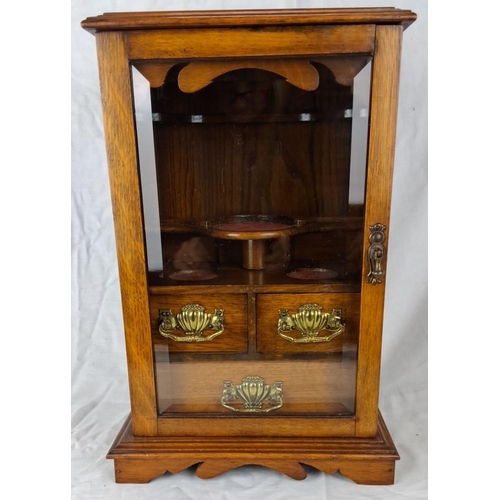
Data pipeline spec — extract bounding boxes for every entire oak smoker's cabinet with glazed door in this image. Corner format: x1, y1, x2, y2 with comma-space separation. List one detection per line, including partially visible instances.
82, 8, 416, 484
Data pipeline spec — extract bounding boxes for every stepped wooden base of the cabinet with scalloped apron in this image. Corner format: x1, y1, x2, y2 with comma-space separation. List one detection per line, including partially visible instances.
107, 414, 399, 485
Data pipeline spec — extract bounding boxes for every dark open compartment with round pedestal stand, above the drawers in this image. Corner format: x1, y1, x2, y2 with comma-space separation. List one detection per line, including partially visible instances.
133, 56, 371, 286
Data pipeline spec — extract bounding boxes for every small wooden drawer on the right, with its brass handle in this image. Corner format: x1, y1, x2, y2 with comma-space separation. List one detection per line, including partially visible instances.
257, 293, 360, 354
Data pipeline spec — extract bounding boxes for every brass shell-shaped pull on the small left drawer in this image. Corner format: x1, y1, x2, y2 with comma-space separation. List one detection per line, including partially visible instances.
158, 304, 224, 342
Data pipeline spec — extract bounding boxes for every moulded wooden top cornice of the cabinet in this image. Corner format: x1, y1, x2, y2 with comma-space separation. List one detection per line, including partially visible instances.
82, 7, 417, 33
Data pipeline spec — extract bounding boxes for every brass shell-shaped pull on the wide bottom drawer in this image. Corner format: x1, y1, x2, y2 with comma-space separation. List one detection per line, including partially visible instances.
220, 377, 283, 412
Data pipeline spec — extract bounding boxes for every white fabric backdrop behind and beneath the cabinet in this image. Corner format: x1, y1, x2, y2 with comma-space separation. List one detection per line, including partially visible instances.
71, 0, 427, 500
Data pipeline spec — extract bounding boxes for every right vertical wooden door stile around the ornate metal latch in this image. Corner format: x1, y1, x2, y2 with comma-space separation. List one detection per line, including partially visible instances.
356, 26, 403, 437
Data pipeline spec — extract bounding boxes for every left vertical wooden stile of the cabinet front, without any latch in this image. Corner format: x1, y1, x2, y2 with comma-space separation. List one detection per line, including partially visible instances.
96, 32, 157, 436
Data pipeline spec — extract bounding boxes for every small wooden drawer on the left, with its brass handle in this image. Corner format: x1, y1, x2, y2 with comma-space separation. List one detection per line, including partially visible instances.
150, 293, 248, 353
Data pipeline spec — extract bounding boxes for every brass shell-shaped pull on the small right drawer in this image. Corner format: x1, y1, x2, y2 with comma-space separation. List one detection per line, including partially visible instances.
278, 304, 345, 343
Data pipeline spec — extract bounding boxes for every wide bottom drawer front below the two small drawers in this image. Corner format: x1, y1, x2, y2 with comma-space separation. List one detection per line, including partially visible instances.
156, 357, 356, 418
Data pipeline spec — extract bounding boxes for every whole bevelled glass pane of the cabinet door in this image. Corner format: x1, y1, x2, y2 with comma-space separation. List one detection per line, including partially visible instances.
132, 56, 371, 416
